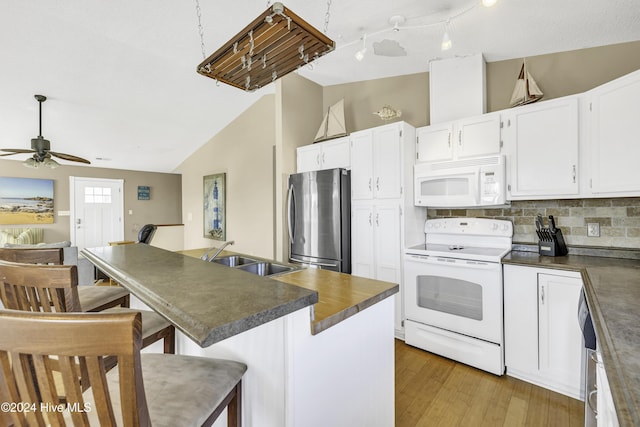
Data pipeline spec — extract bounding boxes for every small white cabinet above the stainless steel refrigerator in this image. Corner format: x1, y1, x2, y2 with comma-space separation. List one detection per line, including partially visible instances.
296, 136, 351, 172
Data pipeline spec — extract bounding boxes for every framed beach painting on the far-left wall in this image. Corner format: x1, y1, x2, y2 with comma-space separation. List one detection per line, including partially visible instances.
0, 177, 53, 224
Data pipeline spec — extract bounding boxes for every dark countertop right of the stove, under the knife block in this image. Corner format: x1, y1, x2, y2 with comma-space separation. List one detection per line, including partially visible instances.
502, 251, 640, 426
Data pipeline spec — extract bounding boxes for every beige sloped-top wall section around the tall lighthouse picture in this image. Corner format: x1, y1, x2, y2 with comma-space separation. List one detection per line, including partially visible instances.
175, 95, 275, 258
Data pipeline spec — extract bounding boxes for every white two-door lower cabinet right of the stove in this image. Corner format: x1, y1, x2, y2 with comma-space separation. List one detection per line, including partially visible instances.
503, 265, 584, 399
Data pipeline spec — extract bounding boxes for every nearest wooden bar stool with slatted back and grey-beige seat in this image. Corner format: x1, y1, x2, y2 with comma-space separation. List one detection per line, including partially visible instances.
0, 310, 247, 427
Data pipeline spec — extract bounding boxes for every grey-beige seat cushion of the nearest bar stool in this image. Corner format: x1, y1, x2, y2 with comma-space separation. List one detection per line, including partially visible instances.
70, 353, 247, 427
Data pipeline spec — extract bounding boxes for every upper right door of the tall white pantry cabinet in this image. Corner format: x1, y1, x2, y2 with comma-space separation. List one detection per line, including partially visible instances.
373, 126, 403, 199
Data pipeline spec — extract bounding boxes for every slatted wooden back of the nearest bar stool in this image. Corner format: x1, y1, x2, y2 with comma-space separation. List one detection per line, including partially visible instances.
0, 310, 151, 427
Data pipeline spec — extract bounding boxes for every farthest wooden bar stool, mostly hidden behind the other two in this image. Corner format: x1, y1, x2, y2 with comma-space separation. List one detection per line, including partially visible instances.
0, 248, 129, 311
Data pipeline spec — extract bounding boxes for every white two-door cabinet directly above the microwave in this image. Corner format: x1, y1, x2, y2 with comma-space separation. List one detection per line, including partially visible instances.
416, 113, 501, 162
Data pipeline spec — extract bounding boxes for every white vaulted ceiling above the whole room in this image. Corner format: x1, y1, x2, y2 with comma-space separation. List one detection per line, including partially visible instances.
0, 0, 640, 172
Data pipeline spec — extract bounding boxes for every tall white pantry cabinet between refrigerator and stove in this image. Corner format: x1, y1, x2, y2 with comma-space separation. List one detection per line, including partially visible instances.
351, 122, 426, 338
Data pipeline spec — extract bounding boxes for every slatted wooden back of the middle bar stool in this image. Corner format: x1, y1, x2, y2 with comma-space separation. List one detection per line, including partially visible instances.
0, 261, 81, 312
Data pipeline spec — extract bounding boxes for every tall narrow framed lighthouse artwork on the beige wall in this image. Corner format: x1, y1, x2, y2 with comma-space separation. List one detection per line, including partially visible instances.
203, 173, 227, 240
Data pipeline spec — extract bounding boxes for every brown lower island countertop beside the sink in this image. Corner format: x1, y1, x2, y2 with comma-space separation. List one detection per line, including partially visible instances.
180, 249, 400, 335
